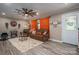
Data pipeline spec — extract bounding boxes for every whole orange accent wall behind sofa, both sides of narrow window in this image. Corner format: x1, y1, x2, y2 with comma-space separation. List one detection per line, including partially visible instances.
31, 17, 50, 30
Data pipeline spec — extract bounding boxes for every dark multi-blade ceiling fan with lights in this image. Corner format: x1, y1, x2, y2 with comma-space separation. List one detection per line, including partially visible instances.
16, 8, 38, 17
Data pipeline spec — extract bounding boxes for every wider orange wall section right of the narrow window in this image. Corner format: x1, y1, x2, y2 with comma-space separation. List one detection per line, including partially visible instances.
40, 17, 49, 30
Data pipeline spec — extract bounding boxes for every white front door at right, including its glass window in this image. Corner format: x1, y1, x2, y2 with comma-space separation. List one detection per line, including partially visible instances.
62, 14, 78, 45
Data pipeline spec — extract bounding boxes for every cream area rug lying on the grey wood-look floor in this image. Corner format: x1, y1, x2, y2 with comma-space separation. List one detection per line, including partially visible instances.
9, 37, 43, 53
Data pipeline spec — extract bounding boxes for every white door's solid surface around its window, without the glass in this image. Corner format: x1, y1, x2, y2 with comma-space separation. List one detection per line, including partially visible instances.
62, 14, 78, 45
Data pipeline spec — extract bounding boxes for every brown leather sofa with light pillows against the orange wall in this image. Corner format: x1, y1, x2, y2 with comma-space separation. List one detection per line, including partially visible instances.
30, 29, 49, 42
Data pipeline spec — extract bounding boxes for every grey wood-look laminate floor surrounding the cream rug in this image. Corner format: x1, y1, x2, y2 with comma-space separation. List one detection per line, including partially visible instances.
0, 40, 79, 55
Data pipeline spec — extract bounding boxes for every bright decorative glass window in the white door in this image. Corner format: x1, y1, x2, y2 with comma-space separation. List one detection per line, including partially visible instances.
65, 16, 76, 30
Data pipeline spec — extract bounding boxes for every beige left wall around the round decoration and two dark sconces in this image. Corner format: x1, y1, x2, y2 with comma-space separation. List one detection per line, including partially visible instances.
0, 17, 28, 32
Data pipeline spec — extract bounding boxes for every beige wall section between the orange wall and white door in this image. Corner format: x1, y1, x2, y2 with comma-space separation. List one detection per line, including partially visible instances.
50, 15, 62, 41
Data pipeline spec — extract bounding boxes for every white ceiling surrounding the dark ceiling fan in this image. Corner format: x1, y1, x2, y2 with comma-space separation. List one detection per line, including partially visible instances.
0, 3, 79, 19
